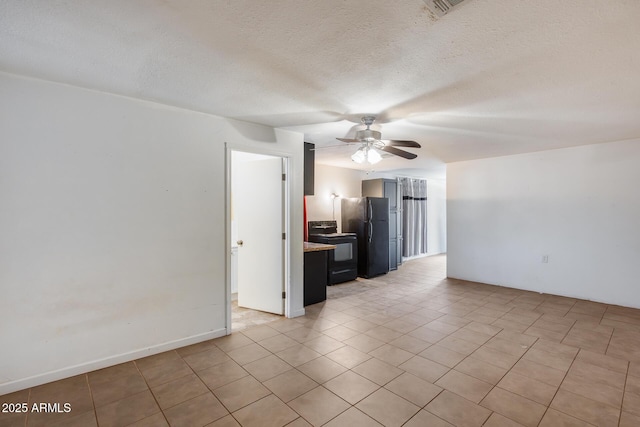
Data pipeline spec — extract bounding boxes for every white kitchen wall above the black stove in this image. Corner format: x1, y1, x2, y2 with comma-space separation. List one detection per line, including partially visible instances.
306, 163, 366, 230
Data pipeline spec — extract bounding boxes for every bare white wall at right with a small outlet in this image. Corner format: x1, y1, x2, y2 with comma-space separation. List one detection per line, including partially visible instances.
447, 140, 640, 307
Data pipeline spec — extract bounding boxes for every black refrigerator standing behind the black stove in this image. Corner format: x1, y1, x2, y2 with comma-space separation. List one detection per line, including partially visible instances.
341, 197, 389, 279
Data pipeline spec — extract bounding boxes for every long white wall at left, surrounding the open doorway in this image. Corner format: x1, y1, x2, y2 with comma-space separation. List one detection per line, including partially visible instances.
0, 74, 303, 394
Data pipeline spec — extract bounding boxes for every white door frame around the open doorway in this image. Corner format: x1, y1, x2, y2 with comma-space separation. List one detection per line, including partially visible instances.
224, 142, 291, 335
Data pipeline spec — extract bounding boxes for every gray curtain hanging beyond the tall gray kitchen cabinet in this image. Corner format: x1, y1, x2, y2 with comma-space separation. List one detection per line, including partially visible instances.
398, 178, 427, 257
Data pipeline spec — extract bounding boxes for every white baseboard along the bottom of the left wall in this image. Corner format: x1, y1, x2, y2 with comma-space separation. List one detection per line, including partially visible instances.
0, 328, 228, 396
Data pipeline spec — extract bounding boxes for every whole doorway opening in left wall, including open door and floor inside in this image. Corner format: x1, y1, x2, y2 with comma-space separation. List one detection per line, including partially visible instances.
227, 149, 288, 332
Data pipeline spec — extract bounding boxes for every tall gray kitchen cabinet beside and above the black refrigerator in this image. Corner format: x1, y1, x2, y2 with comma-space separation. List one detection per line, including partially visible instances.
362, 178, 402, 270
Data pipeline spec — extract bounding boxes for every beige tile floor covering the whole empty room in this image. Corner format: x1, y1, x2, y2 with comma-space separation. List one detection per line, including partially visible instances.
0, 256, 640, 427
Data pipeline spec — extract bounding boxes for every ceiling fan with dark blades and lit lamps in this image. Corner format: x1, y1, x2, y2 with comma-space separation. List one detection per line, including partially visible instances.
336, 116, 420, 164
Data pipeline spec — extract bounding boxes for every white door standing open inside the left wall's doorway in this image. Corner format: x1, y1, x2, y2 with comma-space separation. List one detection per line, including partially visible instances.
231, 152, 284, 314
